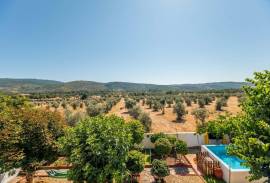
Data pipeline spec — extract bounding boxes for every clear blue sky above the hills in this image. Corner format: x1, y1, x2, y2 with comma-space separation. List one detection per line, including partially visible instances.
0, 0, 270, 84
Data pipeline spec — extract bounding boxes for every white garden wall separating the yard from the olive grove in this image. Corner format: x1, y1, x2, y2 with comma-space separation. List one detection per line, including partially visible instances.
142, 132, 204, 149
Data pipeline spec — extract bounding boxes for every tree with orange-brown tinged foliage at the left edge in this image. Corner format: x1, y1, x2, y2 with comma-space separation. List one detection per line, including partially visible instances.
0, 95, 64, 182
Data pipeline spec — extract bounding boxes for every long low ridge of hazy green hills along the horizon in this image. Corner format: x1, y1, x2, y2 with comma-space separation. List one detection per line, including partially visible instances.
0, 78, 248, 93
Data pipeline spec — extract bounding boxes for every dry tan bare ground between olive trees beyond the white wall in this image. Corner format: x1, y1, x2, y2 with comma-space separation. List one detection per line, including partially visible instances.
109, 97, 241, 133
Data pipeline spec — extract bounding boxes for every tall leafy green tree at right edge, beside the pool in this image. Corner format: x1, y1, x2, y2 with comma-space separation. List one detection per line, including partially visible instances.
229, 71, 270, 183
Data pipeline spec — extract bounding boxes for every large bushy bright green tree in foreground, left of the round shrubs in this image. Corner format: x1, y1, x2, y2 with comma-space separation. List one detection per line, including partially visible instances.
60, 116, 132, 183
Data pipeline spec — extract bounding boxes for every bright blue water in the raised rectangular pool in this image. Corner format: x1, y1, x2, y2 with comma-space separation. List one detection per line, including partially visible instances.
206, 145, 249, 170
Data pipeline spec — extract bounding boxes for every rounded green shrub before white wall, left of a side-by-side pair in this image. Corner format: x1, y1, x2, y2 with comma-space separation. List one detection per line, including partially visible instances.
155, 138, 172, 158
